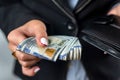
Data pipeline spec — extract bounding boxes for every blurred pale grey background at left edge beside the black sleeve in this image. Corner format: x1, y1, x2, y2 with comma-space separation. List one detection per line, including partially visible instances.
0, 29, 21, 80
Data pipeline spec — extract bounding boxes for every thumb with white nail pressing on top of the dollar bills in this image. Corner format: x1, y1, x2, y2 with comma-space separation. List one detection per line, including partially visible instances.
24, 20, 48, 46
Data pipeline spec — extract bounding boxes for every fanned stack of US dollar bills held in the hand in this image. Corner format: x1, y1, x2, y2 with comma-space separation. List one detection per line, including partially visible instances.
17, 35, 81, 61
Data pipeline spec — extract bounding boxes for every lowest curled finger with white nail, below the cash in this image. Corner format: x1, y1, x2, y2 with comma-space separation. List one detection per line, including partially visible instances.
22, 66, 40, 76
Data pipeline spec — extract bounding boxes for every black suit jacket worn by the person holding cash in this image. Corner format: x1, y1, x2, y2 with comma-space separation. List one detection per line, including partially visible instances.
0, 0, 120, 80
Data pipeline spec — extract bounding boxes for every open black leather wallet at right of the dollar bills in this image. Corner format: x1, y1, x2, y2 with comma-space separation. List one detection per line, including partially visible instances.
82, 15, 120, 59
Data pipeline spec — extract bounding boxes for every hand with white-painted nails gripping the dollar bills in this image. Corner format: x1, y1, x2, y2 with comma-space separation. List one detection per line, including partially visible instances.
8, 20, 48, 76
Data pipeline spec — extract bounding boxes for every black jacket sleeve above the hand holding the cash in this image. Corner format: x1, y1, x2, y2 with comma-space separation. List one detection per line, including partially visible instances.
0, 2, 42, 36
